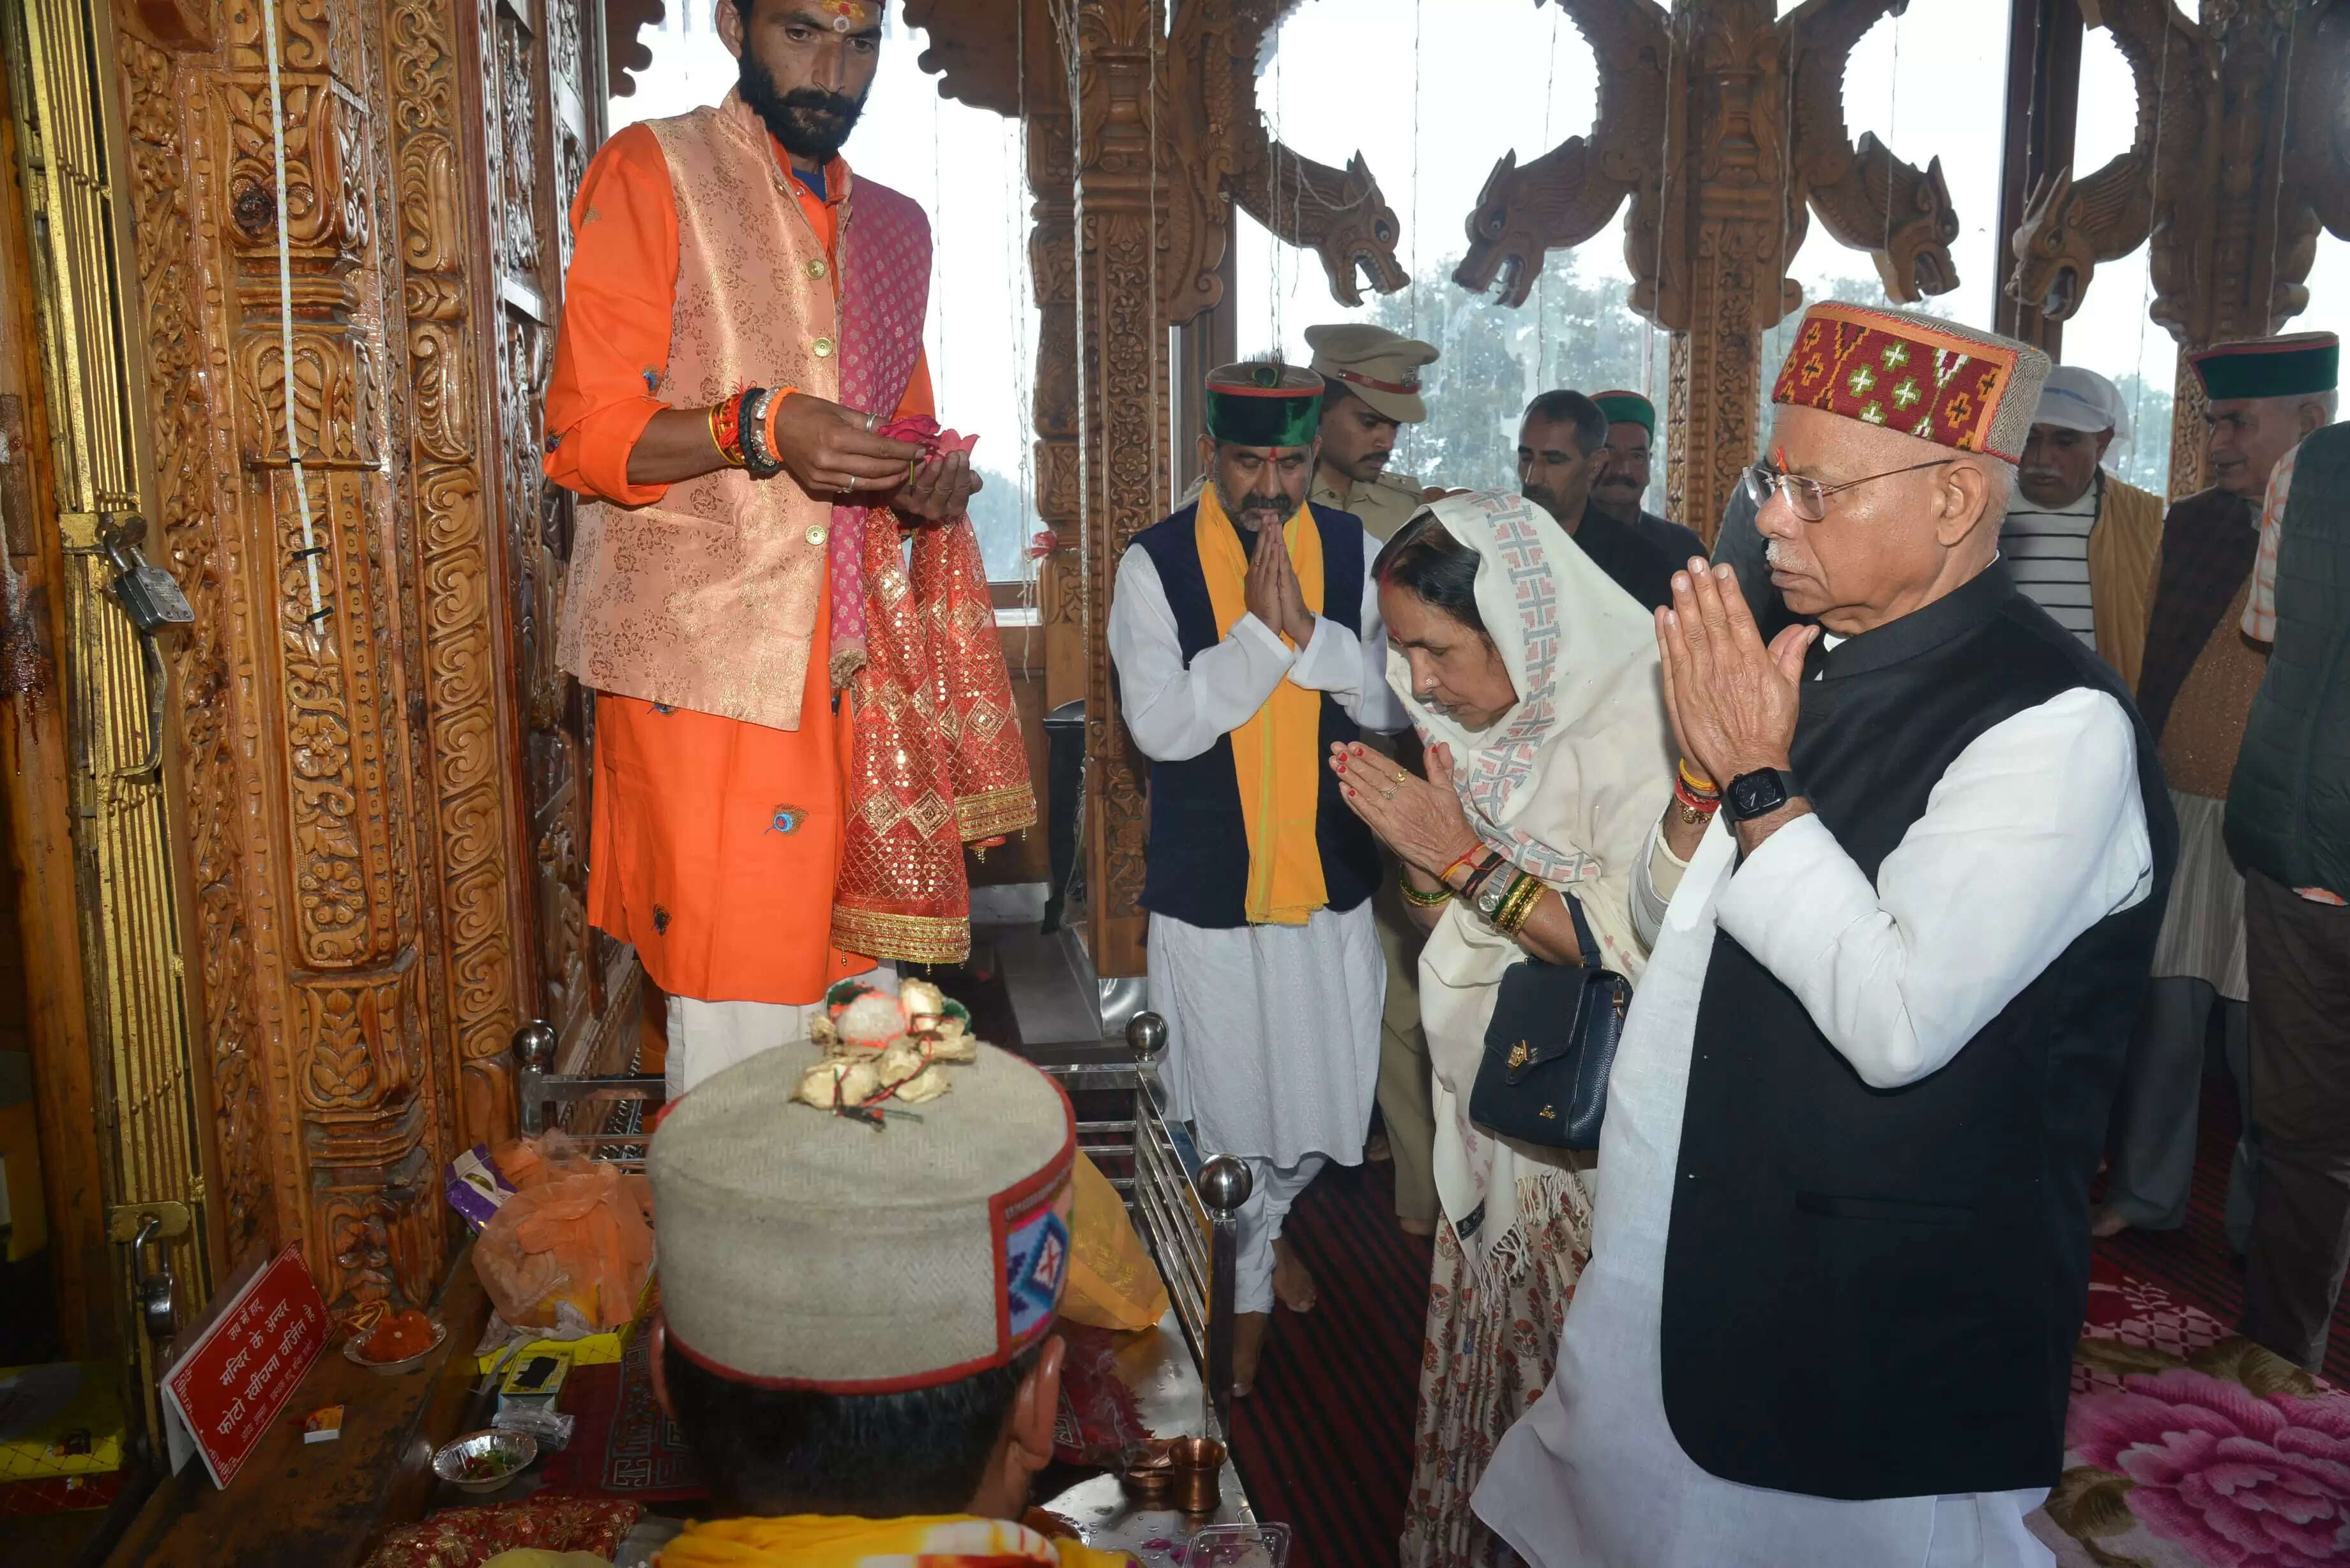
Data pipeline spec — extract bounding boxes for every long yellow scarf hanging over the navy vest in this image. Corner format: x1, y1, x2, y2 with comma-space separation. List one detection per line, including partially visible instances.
1194, 485, 1330, 926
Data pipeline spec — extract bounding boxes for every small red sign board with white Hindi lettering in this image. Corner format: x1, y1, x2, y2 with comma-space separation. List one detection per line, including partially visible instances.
162, 1246, 327, 1486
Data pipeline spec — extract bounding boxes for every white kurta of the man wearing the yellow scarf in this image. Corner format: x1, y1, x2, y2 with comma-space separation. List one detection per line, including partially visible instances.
1109, 548, 1403, 1166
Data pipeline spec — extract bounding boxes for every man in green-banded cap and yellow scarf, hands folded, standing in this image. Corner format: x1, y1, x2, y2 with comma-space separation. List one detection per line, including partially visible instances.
1109, 365, 1403, 1392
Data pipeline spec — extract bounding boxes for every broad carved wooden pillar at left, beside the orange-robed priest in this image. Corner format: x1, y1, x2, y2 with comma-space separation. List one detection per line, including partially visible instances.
120, 0, 588, 1305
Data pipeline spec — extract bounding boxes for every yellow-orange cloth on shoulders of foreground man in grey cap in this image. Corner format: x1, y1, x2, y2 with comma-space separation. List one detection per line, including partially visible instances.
656, 1514, 1133, 1568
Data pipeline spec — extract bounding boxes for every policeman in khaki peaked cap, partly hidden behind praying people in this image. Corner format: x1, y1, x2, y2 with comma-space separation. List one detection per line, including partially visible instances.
1307, 322, 1436, 543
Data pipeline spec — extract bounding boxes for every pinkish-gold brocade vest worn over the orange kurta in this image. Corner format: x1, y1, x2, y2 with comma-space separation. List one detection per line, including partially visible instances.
554, 92, 853, 728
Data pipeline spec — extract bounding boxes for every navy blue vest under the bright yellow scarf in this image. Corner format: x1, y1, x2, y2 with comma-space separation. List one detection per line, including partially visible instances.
1135, 503, 1379, 931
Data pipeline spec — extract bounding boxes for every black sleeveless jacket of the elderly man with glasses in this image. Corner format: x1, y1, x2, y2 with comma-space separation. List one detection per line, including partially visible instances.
1662, 566, 2178, 1500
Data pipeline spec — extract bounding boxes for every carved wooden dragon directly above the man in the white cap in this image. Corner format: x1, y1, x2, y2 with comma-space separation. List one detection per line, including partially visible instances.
2007, 0, 2218, 322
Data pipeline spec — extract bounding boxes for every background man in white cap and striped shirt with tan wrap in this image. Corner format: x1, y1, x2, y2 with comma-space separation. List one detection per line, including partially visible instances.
2000, 365, 2162, 686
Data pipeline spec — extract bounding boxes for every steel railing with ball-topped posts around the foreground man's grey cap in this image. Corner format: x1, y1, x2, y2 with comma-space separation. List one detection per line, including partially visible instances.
515, 1013, 1250, 1438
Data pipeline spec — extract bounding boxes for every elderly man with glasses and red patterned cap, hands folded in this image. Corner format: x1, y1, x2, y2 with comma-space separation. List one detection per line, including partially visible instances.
1476, 303, 2176, 1568
